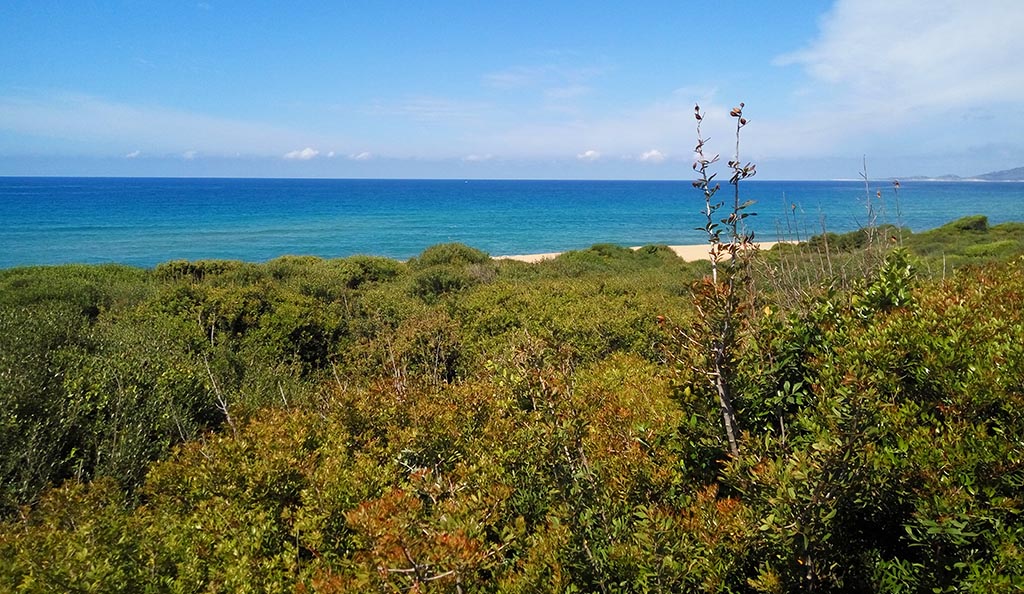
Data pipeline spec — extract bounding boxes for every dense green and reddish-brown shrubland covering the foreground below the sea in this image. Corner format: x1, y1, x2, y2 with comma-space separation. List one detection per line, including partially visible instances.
0, 219, 1024, 593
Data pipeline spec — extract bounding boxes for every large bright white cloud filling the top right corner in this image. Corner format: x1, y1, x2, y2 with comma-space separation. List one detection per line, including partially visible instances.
777, 0, 1024, 107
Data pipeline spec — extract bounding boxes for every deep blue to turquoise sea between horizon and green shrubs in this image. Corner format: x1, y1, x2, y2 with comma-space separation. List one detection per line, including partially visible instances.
0, 177, 1024, 267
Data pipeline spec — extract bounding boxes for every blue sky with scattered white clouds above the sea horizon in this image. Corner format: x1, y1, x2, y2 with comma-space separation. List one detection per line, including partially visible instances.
0, 0, 1024, 179
